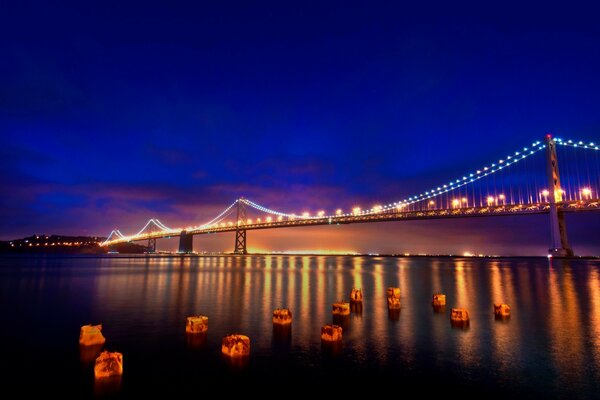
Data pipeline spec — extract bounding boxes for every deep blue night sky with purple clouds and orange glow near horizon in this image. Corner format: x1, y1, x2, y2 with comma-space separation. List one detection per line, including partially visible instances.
0, 1, 600, 254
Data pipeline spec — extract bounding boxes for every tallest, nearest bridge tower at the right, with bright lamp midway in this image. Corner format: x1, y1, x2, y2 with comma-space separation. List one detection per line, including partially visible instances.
546, 135, 574, 257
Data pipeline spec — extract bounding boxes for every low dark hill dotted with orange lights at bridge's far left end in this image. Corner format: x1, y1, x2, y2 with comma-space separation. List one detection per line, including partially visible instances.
0, 235, 146, 254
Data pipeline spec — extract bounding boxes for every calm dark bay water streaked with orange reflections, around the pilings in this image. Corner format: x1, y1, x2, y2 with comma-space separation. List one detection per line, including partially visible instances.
0, 256, 600, 398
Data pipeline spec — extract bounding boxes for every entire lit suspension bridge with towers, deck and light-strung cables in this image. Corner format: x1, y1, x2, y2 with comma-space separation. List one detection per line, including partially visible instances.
102, 135, 600, 256
